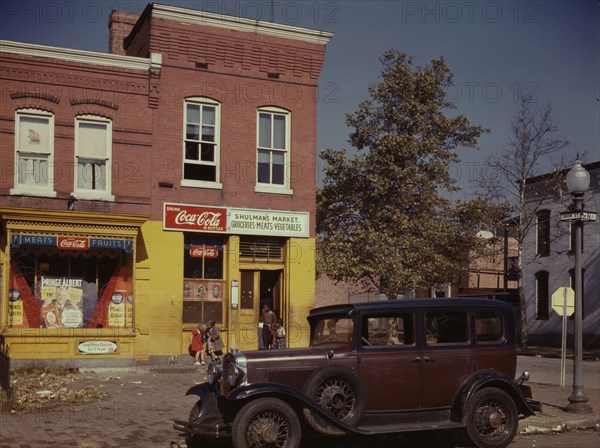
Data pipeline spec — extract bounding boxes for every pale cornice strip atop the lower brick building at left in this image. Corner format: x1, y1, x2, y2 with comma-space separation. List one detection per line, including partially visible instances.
0, 40, 151, 71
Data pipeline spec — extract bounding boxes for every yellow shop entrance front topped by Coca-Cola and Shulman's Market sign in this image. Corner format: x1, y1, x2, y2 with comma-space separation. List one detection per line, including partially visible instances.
162, 203, 315, 353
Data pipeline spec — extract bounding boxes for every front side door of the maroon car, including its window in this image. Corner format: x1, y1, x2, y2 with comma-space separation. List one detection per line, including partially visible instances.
358, 312, 421, 412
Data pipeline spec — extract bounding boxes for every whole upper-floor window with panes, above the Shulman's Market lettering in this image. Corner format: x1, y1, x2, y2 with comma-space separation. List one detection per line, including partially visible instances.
256, 108, 291, 193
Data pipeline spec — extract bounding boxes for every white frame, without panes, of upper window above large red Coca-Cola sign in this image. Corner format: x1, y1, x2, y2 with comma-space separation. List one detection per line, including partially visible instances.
181, 96, 223, 190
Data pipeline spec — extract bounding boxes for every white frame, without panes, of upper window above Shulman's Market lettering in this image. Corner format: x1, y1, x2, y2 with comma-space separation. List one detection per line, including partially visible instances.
254, 107, 294, 195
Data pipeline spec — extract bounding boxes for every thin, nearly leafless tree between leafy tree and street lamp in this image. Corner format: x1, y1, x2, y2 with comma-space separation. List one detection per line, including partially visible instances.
477, 97, 569, 346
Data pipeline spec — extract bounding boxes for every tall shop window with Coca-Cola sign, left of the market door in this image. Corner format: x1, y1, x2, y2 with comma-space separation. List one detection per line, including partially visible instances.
183, 235, 225, 324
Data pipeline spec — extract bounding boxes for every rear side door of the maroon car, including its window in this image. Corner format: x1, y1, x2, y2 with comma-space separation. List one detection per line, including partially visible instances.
421, 309, 475, 408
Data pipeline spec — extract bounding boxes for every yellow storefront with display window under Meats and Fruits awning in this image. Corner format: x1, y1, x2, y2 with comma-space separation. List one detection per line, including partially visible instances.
0, 208, 147, 366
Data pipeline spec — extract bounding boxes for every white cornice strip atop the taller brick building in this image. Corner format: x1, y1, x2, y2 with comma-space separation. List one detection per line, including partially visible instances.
152, 3, 333, 45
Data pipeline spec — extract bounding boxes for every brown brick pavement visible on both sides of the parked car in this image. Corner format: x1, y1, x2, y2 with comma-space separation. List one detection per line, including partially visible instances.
0, 356, 600, 448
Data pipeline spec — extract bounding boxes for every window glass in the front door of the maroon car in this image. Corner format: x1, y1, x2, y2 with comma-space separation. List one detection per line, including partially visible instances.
361, 313, 415, 347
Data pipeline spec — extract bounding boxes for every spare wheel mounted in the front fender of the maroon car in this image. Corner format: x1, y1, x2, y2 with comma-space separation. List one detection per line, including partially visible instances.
304, 365, 367, 435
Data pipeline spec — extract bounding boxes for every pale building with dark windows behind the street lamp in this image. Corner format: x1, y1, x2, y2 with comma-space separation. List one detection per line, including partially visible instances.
522, 162, 600, 350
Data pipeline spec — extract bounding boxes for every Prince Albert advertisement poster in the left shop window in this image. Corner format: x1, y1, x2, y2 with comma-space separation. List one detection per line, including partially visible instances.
40, 276, 83, 328
